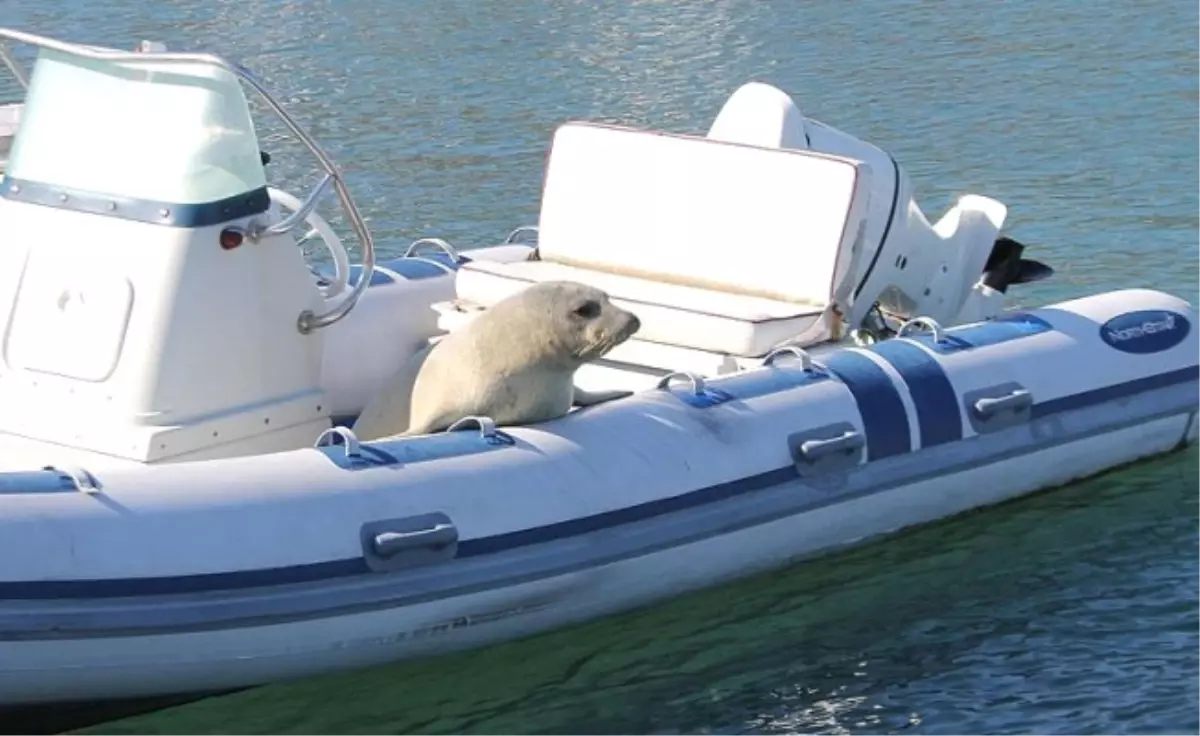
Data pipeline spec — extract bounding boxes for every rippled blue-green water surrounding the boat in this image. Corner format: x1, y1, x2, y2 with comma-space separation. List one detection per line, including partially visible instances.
7, 0, 1200, 736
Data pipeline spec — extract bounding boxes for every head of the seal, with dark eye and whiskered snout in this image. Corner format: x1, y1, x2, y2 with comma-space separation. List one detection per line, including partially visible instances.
488, 281, 642, 367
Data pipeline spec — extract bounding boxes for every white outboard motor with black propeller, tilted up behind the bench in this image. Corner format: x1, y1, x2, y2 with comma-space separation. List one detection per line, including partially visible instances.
708, 82, 1049, 329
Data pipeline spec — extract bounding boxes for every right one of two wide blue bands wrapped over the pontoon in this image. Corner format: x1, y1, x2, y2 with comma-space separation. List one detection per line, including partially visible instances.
870, 339, 962, 448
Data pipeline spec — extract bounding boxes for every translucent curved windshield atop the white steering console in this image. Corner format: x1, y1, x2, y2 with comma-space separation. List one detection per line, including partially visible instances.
5, 49, 266, 204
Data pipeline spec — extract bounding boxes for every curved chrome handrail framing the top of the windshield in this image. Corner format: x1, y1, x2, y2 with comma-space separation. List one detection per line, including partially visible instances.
0, 28, 374, 334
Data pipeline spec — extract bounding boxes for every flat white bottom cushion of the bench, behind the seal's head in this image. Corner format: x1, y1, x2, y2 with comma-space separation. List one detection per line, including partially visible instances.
456, 261, 830, 358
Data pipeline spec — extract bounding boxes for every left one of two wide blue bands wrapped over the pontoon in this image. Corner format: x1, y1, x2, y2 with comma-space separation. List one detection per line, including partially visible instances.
824, 351, 912, 461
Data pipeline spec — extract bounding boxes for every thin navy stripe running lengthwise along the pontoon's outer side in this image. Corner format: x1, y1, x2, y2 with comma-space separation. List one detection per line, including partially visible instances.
0, 357, 1200, 600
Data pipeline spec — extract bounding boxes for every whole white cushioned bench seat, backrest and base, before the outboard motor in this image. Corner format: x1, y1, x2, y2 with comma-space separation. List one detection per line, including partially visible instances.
446, 122, 870, 358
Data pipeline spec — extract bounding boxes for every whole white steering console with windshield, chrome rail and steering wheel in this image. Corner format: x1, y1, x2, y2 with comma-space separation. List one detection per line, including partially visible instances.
0, 30, 374, 462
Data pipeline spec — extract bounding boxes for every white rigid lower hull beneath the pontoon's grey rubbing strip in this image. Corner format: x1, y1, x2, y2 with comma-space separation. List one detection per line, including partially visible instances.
0, 412, 1189, 704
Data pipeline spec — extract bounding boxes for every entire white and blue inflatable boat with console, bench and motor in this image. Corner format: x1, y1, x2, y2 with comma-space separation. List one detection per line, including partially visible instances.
0, 29, 1200, 704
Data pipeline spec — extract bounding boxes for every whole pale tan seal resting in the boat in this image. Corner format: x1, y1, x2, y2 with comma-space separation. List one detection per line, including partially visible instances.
354, 281, 642, 441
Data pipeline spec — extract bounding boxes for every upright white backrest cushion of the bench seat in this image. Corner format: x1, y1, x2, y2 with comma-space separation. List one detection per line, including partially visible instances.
538, 122, 871, 305
